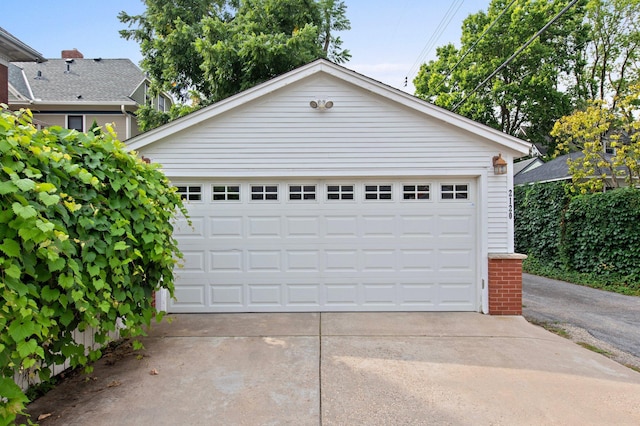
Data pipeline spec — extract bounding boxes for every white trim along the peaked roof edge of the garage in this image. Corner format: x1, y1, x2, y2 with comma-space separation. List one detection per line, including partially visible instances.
127, 59, 531, 154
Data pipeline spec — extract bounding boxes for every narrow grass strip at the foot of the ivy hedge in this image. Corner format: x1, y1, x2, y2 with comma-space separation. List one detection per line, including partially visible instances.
522, 256, 640, 296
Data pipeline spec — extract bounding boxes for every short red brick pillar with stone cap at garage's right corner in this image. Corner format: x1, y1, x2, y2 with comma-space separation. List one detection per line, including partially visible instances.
489, 253, 527, 315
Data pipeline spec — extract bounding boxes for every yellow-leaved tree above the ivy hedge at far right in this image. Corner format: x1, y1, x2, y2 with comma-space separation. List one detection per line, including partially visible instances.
551, 84, 640, 194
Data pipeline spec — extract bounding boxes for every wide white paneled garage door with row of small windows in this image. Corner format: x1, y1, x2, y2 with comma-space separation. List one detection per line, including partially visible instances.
168, 178, 479, 312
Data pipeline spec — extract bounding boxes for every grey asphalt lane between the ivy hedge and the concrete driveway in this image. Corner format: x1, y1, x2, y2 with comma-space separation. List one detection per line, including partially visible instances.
522, 274, 640, 358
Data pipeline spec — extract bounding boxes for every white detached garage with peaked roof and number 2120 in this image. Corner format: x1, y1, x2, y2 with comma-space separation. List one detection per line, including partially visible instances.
128, 60, 529, 313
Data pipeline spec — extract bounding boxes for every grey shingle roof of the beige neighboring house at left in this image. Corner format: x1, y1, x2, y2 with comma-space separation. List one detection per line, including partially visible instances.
9, 58, 146, 104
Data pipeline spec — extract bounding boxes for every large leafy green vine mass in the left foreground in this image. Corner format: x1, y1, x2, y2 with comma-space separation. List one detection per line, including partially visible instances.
0, 111, 185, 423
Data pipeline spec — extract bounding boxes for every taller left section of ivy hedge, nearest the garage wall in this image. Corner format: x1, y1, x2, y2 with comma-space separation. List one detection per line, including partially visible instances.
514, 182, 569, 265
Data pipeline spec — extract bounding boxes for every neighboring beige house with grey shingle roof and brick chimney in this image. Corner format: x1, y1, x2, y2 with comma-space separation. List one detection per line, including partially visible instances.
9, 49, 172, 140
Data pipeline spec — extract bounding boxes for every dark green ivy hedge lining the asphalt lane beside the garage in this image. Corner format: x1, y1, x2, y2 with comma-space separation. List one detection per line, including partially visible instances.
515, 183, 640, 294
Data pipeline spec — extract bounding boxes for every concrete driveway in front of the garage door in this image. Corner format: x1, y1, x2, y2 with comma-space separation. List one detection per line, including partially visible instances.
20, 313, 640, 426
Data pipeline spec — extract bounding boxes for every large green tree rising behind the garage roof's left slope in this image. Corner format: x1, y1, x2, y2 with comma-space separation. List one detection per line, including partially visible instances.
119, 0, 350, 130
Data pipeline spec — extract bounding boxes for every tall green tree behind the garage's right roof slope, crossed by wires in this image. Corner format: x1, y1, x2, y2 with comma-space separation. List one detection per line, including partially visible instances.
414, 0, 588, 151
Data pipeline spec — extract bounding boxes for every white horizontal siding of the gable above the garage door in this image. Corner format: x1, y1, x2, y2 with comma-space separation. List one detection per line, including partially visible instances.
141, 76, 497, 177
